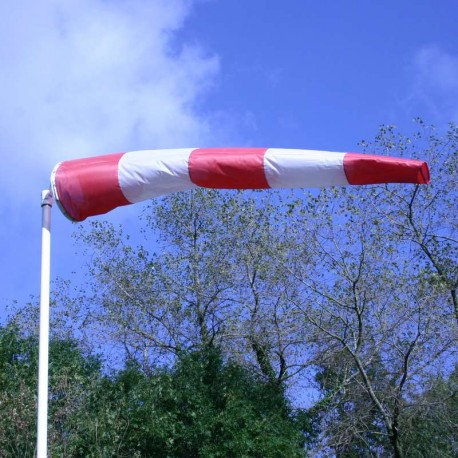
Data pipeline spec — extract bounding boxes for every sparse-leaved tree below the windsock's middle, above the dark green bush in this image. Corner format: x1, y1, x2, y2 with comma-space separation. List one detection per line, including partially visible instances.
71, 190, 314, 384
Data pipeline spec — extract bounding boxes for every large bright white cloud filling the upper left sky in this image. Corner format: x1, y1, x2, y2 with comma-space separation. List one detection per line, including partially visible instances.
0, 0, 218, 195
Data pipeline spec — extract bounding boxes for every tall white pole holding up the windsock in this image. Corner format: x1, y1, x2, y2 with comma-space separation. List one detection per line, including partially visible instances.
37, 190, 53, 458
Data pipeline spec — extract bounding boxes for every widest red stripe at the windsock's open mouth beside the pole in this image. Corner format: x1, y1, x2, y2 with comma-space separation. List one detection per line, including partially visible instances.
53, 153, 130, 221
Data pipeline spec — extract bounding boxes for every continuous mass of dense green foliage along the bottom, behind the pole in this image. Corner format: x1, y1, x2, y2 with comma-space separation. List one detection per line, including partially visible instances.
0, 325, 306, 458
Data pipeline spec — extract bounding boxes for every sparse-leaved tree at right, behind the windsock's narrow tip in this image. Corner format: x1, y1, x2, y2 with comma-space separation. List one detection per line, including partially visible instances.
290, 120, 458, 457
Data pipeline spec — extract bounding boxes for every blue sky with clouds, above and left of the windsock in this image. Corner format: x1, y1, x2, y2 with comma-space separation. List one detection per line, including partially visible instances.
0, 0, 458, 315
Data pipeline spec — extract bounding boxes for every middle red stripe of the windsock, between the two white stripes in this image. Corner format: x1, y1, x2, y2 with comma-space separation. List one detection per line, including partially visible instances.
189, 148, 269, 189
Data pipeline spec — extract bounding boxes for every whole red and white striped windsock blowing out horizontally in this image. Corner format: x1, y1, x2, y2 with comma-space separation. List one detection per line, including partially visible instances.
51, 148, 429, 221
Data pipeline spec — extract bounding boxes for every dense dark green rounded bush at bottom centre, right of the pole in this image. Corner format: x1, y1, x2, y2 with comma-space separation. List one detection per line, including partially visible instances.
75, 350, 305, 457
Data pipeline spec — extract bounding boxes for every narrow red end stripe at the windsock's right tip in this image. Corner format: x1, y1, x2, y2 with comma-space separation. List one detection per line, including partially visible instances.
344, 153, 429, 185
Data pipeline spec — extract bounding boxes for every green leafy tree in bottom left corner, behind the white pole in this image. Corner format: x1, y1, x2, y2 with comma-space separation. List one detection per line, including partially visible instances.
0, 321, 101, 457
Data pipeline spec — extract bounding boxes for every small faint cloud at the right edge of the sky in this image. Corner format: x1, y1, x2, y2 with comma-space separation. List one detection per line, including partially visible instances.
410, 46, 458, 122
